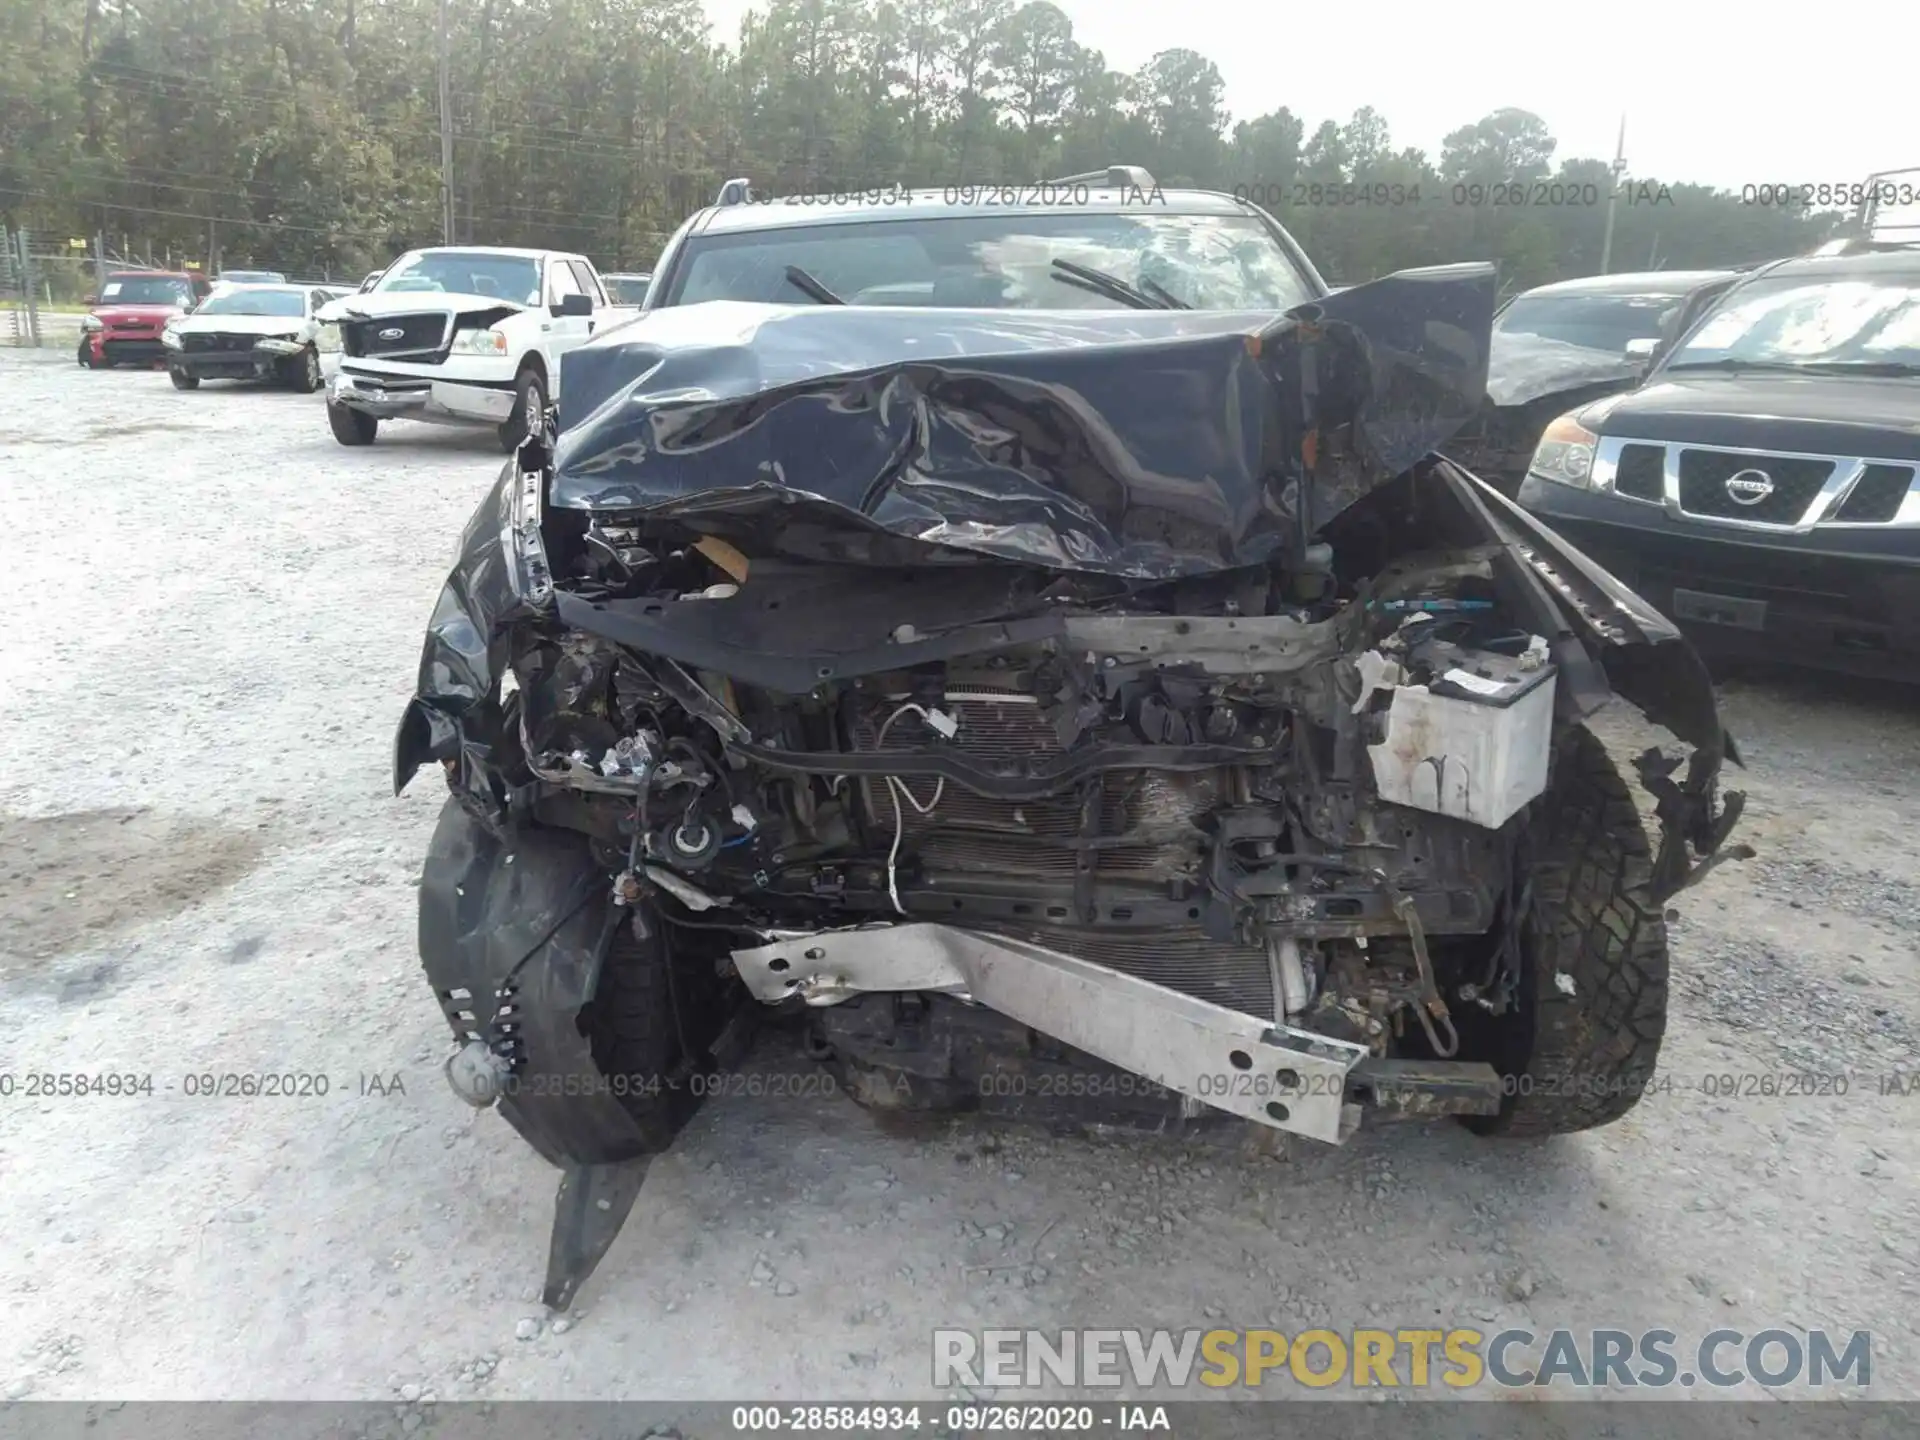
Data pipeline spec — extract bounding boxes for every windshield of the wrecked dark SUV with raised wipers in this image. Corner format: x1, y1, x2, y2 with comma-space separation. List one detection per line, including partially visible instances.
664, 211, 1313, 311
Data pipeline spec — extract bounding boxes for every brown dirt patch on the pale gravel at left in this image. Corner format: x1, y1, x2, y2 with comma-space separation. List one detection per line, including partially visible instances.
0, 808, 267, 975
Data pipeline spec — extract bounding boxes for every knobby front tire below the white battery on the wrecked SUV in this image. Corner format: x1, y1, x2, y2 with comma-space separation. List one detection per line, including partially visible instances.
1453, 726, 1667, 1135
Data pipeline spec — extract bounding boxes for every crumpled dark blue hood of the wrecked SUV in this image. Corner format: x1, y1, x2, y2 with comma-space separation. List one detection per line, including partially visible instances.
549, 265, 1496, 578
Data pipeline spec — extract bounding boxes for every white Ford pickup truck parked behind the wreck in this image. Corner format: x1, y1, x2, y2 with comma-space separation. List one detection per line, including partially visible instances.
319, 246, 639, 451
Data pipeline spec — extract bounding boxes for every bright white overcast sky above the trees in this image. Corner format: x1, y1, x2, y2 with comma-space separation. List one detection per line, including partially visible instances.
705, 0, 1920, 190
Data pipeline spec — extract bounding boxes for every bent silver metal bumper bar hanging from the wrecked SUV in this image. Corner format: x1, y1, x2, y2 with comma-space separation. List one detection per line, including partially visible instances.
733, 924, 1367, 1144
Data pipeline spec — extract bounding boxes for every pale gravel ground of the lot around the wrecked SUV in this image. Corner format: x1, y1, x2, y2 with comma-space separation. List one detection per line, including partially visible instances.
0, 351, 1920, 1402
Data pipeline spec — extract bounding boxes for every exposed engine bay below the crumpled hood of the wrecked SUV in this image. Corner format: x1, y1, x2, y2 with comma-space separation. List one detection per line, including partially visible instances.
511, 518, 1553, 1054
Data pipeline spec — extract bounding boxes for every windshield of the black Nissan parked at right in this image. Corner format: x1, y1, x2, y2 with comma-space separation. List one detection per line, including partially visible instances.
1667, 271, 1920, 372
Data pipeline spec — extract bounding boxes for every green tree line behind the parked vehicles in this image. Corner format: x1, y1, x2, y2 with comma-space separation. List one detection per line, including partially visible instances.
0, 0, 1834, 288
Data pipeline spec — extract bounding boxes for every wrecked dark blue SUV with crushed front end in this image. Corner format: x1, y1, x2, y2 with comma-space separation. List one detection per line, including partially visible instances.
385, 174, 1740, 1306
